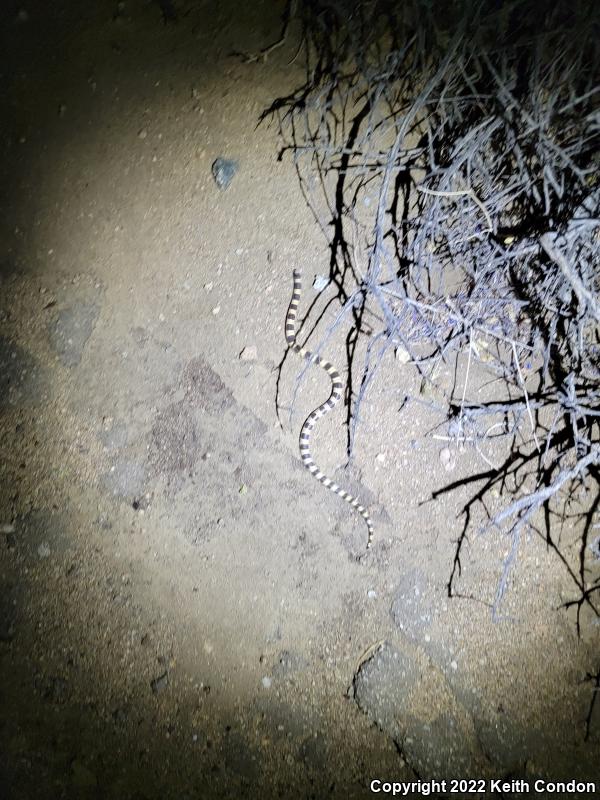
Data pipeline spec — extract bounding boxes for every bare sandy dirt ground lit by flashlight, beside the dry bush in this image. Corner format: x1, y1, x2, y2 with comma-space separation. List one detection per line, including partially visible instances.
0, 0, 600, 800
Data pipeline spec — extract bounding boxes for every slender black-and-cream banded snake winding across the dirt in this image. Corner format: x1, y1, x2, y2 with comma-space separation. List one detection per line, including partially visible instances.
285, 269, 374, 550
